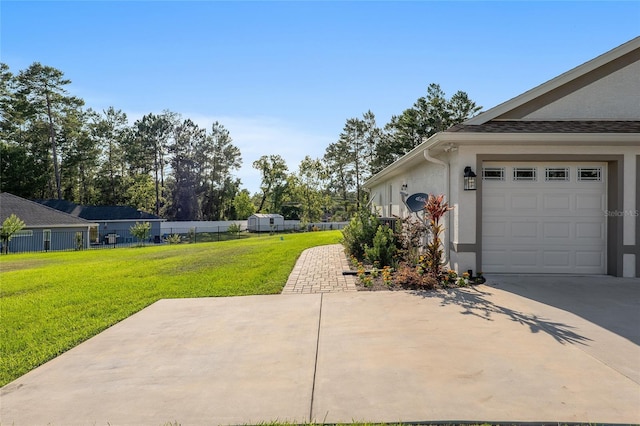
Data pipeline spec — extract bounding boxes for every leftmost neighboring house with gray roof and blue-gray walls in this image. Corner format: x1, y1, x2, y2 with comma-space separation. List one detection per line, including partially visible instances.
0, 192, 98, 253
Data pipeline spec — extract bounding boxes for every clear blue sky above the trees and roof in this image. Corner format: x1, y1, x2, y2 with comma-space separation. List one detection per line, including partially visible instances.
0, 0, 640, 192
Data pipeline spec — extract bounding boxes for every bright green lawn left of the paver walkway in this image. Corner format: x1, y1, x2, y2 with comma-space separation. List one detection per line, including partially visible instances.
0, 231, 341, 386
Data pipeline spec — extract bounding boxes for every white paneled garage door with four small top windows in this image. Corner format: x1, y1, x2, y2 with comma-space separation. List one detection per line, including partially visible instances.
482, 162, 606, 274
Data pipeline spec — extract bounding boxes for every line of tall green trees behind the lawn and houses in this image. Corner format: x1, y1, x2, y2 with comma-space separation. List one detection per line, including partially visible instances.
0, 62, 480, 222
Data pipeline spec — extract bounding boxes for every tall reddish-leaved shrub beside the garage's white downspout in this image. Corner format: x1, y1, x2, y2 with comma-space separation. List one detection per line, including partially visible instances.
423, 195, 453, 282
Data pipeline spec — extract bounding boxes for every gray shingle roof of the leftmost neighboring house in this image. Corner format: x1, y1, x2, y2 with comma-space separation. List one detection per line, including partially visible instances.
0, 192, 93, 228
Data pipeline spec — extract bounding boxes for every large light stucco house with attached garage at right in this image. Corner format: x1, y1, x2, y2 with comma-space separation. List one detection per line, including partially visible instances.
365, 37, 640, 277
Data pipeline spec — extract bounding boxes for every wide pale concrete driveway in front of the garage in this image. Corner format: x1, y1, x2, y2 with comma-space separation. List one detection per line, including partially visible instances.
0, 276, 640, 426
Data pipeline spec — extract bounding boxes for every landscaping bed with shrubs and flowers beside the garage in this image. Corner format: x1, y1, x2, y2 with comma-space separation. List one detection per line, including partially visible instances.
342, 195, 485, 291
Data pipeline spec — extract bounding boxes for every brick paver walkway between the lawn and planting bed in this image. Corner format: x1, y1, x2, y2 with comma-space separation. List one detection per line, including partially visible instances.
282, 244, 357, 294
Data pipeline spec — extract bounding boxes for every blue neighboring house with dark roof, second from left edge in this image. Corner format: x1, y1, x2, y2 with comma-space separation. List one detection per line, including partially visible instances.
37, 200, 164, 244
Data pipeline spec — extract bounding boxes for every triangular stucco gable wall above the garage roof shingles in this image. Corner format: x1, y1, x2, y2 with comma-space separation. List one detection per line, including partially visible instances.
523, 62, 640, 120
